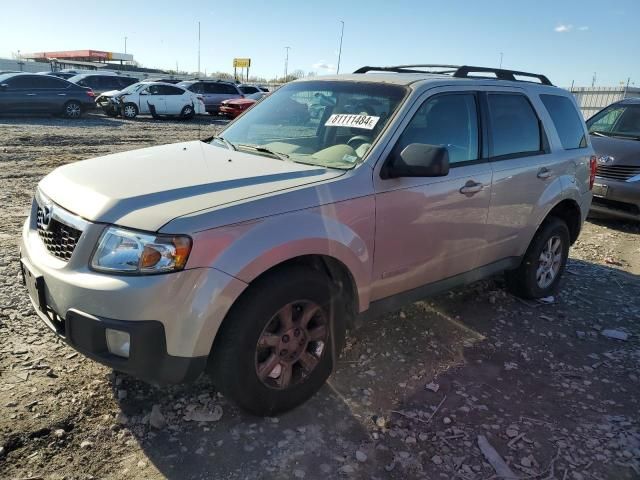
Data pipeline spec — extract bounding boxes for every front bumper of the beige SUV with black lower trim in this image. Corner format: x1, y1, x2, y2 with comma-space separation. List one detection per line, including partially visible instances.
20, 198, 246, 383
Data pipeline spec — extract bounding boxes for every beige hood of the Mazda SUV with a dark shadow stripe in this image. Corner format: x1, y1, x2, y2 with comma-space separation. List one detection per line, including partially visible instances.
38, 141, 344, 233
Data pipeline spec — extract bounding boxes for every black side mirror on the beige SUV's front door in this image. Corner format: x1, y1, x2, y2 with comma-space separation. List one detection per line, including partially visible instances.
383, 143, 449, 178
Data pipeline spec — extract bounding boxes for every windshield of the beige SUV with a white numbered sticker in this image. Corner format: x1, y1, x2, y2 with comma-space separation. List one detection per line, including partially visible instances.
214, 81, 407, 169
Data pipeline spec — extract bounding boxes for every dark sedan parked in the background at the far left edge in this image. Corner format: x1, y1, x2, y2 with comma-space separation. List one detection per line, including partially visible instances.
0, 73, 95, 118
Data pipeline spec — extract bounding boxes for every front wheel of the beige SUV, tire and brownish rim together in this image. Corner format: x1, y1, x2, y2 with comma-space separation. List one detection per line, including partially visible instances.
209, 267, 345, 415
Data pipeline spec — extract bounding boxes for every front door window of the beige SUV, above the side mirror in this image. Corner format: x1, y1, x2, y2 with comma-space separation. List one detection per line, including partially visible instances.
396, 93, 478, 164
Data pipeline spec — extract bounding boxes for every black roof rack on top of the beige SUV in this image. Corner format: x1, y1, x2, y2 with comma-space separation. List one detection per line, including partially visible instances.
353, 64, 553, 85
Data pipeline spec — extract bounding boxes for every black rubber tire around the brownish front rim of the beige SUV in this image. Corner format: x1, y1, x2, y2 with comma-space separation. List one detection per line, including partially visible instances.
209, 266, 345, 416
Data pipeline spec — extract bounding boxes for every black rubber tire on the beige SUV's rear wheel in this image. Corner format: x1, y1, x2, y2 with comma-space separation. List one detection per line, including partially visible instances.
505, 217, 570, 298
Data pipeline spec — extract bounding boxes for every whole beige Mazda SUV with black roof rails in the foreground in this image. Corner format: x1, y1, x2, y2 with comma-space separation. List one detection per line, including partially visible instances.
21, 65, 596, 414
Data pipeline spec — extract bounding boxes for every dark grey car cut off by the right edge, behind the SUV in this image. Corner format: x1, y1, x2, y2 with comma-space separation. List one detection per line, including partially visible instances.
587, 98, 640, 221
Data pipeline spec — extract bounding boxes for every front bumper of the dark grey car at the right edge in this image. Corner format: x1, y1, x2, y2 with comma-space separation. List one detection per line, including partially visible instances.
591, 177, 640, 220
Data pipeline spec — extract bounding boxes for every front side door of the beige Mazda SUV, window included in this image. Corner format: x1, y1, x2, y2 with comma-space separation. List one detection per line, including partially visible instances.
372, 88, 491, 300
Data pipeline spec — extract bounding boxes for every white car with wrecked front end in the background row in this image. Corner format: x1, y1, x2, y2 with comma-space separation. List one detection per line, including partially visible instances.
96, 82, 206, 119
